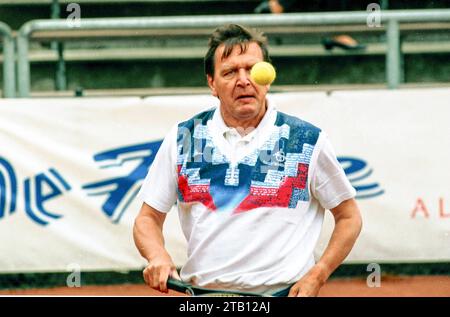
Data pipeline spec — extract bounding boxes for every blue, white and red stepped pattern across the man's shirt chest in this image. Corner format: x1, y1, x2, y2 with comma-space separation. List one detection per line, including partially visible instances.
177, 109, 320, 213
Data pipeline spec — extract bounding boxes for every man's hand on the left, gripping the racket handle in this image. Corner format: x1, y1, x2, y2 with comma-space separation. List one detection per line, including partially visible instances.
143, 255, 181, 293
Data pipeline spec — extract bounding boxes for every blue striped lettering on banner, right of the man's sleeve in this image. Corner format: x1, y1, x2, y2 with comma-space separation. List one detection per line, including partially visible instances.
338, 156, 384, 199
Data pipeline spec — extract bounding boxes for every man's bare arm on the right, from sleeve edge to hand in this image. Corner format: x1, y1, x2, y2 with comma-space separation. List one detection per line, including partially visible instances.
289, 198, 362, 297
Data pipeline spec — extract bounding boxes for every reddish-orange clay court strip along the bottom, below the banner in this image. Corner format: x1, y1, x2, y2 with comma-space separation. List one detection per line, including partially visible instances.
0, 276, 450, 297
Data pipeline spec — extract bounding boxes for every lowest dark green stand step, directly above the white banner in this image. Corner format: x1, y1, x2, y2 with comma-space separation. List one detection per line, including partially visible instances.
16, 53, 450, 91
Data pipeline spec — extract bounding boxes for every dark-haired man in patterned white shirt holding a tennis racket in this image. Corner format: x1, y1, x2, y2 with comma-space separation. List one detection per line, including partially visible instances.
134, 24, 361, 296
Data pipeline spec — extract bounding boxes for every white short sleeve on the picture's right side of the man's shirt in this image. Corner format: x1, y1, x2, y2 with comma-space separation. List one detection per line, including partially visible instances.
311, 134, 356, 209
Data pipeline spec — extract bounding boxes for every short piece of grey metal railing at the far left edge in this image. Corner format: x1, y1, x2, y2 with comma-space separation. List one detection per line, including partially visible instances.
0, 22, 16, 98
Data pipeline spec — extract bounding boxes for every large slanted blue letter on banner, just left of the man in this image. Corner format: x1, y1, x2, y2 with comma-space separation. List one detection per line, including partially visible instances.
83, 141, 162, 223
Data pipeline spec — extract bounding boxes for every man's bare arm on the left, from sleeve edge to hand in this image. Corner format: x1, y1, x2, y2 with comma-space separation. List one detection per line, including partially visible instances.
133, 203, 180, 292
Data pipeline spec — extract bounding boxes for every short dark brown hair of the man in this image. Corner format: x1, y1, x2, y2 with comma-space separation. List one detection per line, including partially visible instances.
204, 24, 270, 76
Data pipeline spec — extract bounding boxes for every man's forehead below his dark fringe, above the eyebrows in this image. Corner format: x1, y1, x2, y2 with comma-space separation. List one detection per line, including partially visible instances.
214, 42, 264, 67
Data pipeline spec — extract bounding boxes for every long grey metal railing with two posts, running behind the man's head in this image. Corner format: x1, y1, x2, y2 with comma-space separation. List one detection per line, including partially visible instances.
13, 9, 450, 97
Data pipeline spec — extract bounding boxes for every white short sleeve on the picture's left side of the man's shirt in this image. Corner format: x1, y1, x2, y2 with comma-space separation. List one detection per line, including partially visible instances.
138, 125, 177, 213
